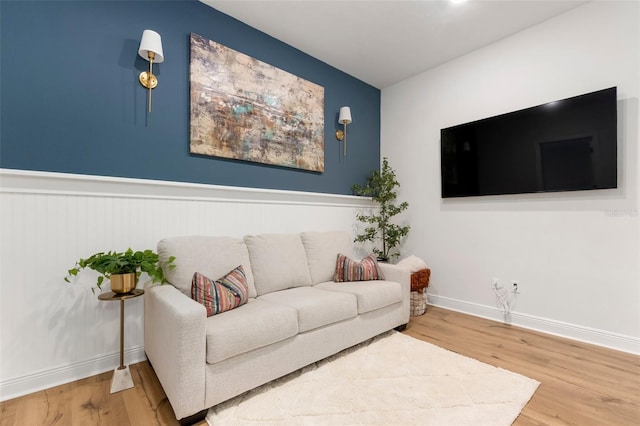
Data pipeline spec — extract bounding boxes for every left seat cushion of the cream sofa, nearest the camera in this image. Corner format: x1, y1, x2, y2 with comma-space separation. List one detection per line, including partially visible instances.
206, 299, 298, 364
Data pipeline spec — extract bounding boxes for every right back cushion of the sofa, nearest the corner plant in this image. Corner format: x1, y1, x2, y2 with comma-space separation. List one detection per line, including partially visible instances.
300, 231, 353, 284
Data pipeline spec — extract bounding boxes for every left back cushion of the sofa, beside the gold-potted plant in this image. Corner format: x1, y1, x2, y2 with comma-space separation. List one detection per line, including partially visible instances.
158, 235, 257, 297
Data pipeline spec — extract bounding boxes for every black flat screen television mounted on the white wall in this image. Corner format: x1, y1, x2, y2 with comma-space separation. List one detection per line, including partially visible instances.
440, 87, 618, 198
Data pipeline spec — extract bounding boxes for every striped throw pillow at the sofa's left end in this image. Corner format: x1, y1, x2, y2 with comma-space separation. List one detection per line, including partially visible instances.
191, 265, 249, 317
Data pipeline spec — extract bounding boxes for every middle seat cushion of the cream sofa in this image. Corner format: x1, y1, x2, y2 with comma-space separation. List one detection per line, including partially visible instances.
258, 287, 358, 333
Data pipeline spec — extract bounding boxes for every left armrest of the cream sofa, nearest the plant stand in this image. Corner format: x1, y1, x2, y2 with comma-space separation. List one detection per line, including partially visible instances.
144, 282, 207, 419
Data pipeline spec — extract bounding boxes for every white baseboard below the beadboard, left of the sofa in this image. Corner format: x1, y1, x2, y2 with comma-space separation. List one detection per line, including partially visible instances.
0, 346, 147, 401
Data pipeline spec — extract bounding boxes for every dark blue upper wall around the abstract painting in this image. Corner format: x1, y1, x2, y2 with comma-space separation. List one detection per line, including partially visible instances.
0, 0, 380, 194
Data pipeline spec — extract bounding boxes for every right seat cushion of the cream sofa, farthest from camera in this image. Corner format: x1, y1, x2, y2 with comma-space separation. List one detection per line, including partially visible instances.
314, 281, 402, 314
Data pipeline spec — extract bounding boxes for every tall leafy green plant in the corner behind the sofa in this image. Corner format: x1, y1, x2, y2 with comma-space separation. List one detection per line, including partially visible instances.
351, 157, 411, 261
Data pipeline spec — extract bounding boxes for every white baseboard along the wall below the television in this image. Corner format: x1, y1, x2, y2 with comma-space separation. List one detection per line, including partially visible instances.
428, 294, 640, 355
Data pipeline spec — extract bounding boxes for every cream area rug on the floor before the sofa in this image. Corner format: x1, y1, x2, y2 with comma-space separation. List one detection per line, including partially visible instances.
207, 332, 539, 426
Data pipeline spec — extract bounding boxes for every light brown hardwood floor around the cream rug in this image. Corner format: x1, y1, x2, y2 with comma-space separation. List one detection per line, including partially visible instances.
0, 306, 640, 426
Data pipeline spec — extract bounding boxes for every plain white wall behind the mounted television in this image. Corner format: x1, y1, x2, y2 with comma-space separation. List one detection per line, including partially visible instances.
382, 1, 640, 353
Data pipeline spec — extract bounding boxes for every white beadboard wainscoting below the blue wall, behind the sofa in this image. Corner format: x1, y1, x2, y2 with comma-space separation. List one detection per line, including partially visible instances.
0, 170, 371, 400
